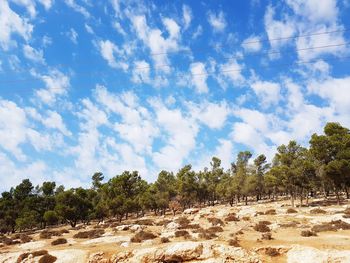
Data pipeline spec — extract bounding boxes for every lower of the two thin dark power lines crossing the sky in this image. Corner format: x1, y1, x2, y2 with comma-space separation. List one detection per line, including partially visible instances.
1, 56, 350, 93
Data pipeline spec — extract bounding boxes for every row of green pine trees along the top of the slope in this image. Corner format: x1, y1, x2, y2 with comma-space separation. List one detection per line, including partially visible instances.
0, 122, 350, 233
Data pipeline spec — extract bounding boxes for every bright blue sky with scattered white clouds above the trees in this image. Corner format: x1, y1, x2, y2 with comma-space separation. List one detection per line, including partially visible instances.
0, 0, 350, 190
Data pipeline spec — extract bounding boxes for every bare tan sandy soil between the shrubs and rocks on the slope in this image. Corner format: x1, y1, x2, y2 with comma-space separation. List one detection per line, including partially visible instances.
0, 201, 350, 263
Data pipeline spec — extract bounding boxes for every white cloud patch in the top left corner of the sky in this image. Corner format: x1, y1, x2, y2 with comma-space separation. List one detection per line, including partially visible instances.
0, 1, 33, 50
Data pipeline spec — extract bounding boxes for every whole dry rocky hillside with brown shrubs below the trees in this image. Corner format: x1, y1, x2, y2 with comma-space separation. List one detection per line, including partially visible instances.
0, 200, 350, 263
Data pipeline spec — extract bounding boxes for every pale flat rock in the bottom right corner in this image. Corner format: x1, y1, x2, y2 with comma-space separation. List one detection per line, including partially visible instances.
287, 245, 350, 263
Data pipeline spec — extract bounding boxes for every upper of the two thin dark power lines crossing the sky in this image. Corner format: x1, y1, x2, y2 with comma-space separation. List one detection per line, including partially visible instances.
0, 42, 350, 84
